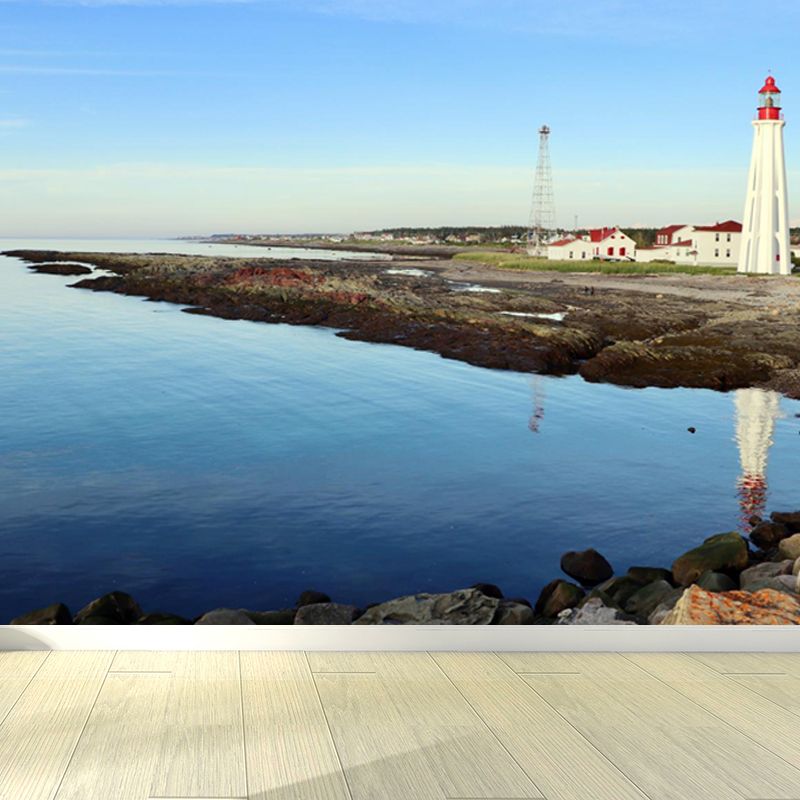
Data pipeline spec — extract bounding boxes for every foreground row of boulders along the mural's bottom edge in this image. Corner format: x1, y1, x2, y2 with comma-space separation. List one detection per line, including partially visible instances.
10, 511, 800, 625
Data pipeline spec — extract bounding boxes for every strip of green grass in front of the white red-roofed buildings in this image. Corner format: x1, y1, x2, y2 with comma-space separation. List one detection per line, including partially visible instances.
454, 252, 736, 275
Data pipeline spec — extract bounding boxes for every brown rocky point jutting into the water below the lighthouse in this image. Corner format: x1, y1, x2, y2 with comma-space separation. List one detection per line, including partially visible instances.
5, 250, 800, 398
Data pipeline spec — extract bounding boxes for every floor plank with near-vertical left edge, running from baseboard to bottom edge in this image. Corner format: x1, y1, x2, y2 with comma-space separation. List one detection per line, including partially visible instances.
241, 652, 351, 800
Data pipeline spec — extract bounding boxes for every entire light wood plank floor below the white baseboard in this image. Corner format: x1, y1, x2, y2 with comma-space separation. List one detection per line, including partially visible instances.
0, 652, 800, 800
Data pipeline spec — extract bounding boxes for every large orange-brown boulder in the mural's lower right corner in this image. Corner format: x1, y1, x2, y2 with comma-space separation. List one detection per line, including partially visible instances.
661, 586, 800, 625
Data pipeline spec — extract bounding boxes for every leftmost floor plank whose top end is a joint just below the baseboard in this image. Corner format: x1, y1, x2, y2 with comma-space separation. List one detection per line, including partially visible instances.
55, 673, 170, 800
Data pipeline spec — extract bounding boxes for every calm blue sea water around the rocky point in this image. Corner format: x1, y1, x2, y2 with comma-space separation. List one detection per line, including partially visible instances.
0, 240, 800, 622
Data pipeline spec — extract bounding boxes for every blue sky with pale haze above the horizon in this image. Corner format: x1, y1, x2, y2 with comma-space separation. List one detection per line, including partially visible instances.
0, 0, 800, 236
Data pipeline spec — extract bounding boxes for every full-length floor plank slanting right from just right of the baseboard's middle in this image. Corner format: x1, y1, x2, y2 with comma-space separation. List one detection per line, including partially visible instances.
433, 653, 648, 800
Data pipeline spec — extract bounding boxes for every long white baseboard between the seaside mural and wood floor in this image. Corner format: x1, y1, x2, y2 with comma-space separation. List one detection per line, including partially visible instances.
0, 625, 800, 653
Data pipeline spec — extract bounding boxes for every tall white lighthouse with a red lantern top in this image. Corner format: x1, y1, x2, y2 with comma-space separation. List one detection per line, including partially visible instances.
739, 75, 792, 275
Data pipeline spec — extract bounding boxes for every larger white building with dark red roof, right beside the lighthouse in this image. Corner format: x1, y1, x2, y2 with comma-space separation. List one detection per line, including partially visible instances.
636, 219, 742, 267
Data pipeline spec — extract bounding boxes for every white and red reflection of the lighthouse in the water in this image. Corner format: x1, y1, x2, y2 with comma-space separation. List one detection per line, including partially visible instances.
735, 389, 782, 531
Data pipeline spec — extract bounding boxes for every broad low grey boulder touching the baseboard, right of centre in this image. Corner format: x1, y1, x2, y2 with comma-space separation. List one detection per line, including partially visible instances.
355, 589, 500, 625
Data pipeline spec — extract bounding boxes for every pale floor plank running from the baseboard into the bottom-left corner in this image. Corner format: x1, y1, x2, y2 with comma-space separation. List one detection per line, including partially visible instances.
0, 652, 113, 800
